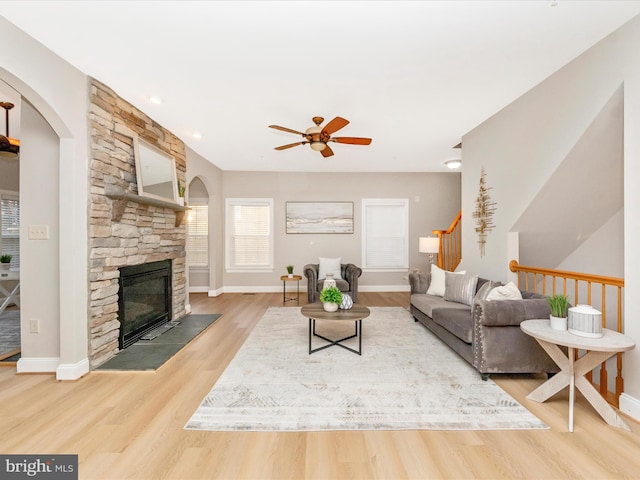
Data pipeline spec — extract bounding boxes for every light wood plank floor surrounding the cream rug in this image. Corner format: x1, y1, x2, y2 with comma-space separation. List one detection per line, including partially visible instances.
0, 293, 640, 480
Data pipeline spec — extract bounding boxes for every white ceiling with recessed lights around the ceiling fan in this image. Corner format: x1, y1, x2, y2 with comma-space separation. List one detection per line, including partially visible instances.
0, 0, 640, 172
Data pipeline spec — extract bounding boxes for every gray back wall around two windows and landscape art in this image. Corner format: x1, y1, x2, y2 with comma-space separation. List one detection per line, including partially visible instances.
221, 171, 460, 291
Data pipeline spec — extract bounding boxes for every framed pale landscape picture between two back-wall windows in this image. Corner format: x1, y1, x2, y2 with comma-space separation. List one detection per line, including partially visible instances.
285, 202, 353, 233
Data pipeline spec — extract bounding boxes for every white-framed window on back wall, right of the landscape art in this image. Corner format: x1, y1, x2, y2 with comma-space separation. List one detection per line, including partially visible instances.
362, 198, 409, 271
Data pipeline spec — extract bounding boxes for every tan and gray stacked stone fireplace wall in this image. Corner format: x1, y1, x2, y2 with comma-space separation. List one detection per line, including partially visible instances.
89, 79, 187, 367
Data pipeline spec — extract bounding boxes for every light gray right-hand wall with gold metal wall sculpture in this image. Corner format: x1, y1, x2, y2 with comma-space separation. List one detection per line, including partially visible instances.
461, 17, 640, 419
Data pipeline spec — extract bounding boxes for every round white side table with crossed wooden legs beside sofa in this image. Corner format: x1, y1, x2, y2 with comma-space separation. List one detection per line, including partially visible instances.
520, 319, 635, 432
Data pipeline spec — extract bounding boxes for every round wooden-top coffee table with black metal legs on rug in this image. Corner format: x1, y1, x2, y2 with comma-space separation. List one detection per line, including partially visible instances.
300, 303, 371, 355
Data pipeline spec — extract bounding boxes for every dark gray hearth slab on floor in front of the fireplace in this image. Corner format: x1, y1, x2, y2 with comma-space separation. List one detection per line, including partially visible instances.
97, 314, 221, 370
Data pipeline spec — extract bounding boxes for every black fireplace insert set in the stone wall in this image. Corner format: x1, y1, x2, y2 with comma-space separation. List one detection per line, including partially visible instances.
118, 260, 172, 349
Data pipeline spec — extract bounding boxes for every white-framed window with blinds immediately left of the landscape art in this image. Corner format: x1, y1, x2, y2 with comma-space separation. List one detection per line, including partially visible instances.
225, 198, 273, 272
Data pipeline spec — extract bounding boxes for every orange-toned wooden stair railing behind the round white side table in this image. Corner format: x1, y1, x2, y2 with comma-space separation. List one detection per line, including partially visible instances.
509, 260, 624, 407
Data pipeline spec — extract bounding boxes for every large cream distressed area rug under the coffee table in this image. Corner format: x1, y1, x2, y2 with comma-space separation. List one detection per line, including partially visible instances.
185, 307, 548, 431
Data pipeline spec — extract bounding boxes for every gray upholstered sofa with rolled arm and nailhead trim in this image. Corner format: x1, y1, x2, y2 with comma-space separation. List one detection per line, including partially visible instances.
409, 273, 559, 380
